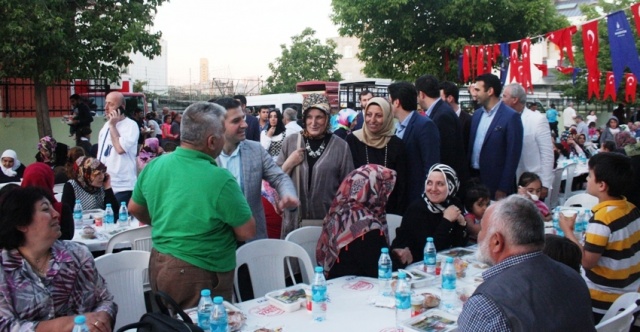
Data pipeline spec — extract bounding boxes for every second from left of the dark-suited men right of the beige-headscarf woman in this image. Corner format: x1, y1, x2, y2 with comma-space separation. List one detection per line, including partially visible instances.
416, 75, 468, 189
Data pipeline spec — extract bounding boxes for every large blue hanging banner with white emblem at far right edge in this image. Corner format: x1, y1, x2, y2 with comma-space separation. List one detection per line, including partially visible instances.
605, 11, 640, 91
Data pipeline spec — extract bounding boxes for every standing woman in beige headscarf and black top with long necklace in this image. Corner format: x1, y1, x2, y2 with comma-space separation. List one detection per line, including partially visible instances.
347, 97, 408, 215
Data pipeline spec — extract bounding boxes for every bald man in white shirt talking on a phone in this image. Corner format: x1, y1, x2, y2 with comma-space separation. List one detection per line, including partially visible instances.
98, 92, 140, 204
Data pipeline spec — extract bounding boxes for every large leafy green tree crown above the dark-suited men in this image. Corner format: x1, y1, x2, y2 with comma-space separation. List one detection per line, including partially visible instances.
332, 0, 568, 80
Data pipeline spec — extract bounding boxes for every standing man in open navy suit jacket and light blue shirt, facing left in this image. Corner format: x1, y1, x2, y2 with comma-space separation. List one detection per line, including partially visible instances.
469, 74, 523, 200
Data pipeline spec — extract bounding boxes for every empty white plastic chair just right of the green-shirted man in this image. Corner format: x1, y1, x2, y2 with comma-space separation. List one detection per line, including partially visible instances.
233, 239, 314, 302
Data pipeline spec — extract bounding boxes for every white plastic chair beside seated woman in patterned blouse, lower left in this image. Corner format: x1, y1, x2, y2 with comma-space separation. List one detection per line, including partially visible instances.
96, 250, 151, 331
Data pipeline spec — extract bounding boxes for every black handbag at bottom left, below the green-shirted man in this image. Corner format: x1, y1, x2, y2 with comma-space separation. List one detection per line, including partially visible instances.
117, 291, 204, 332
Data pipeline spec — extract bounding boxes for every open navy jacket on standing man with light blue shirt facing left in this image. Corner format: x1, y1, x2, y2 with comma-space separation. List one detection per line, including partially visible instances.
469, 103, 523, 199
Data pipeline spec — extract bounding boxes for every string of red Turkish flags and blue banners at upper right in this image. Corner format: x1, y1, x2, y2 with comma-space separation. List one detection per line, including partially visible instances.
458, 3, 640, 103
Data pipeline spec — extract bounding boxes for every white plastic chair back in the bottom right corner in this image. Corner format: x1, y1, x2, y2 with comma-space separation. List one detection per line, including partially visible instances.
596, 292, 640, 332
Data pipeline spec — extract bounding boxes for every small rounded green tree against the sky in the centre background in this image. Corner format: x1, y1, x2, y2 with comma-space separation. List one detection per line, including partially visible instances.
261, 28, 342, 93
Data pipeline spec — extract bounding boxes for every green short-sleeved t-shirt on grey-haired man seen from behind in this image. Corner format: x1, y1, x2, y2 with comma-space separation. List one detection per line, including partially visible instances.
132, 148, 251, 272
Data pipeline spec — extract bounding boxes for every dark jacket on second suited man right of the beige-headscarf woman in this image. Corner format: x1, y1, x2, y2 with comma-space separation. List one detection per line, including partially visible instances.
429, 99, 469, 187
